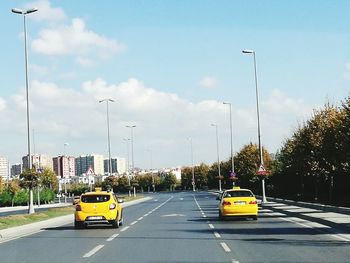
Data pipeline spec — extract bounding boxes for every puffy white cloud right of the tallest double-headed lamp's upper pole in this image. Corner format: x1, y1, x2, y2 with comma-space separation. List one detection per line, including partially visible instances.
32, 18, 125, 59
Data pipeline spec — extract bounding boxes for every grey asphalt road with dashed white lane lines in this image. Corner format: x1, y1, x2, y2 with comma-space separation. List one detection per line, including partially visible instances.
0, 192, 350, 263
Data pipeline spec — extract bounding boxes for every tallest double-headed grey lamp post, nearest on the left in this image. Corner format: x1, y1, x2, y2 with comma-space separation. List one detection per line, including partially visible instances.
11, 8, 38, 214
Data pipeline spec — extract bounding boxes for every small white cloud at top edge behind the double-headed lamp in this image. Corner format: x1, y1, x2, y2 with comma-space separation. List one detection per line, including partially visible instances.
26, 0, 66, 22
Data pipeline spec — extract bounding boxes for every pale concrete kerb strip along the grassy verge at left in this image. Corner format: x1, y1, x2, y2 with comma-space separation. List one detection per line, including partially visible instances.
0, 197, 152, 244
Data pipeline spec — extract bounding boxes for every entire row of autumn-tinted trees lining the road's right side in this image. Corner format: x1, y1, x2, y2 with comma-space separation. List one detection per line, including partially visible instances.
181, 98, 350, 206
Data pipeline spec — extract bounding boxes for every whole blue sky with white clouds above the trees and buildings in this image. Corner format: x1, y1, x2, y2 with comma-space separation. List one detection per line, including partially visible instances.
0, 0, 350, 167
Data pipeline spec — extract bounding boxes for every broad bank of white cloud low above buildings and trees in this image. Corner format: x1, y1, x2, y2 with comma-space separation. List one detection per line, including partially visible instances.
0, 78, 311, 167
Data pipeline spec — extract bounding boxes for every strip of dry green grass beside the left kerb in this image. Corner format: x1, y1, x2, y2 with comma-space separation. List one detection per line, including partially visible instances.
0, 195, 143, 229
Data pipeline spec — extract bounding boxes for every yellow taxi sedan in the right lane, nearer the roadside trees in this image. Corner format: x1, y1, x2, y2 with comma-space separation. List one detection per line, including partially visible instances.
219, 187, 258, 220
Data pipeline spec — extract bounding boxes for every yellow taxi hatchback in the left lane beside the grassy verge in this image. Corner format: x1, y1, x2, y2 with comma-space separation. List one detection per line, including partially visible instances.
74, 191, 123, 228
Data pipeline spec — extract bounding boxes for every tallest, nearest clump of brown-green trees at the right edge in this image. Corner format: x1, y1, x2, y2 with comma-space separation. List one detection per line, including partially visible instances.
271, 98, 350, 206
